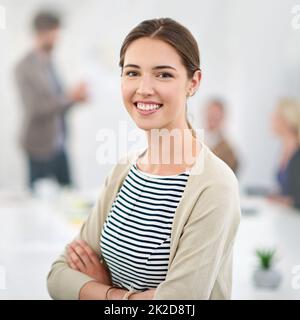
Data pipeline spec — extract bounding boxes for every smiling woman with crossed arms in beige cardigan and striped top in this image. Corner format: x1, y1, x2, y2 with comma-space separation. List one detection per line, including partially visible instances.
48, 18, 240, 300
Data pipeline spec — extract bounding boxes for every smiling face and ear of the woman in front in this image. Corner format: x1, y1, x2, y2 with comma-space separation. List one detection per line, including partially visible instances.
121, 37, 200, 130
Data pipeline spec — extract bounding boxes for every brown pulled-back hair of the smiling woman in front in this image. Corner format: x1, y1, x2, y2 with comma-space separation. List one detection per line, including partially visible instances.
119, 18, 201, 136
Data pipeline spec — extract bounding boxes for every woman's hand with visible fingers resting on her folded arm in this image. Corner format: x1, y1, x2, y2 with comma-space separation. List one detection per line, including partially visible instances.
67, 240, 112, 285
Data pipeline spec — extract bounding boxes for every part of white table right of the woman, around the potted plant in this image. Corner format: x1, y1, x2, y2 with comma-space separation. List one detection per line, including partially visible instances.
232, 198, 300, 300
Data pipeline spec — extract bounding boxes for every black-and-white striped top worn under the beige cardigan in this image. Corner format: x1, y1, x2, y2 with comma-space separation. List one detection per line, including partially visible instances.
100, 163, 189, 290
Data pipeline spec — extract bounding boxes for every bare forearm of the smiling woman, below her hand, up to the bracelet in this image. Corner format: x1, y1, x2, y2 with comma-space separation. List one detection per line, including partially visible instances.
79, 281, 128, 300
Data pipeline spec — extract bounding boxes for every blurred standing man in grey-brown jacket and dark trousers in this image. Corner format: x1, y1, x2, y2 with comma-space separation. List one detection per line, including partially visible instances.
16, 11, 87, 188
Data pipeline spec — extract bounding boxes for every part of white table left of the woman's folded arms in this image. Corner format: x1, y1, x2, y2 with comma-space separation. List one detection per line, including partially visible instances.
0, 189, 84, 299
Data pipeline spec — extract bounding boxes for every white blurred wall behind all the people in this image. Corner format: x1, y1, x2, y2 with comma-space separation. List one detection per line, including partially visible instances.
0, 0, 300, 188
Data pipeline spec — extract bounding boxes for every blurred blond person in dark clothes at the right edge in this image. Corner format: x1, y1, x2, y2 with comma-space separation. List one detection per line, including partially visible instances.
268, 98, 300, 209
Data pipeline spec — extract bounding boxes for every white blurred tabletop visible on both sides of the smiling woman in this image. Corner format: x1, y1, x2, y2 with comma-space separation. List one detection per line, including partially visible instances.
0, 193, 300, 299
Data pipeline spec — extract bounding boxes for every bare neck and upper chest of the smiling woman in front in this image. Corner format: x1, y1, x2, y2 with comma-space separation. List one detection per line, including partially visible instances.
137, 127, 201, 175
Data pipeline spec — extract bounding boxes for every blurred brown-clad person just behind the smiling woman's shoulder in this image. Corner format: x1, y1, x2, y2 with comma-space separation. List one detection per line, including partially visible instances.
205, 99, 238, 173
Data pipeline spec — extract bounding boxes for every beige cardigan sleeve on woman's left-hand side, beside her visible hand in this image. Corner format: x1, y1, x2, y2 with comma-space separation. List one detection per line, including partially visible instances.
47, 172, 109, 300
